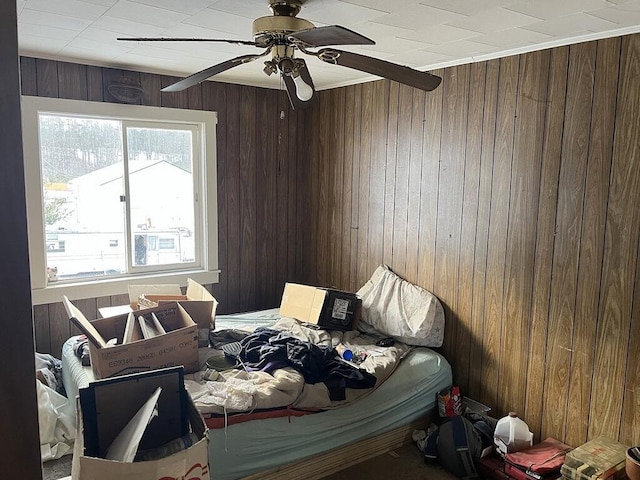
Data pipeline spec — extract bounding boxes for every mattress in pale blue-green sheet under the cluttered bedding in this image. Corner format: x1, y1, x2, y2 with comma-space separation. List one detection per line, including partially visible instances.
62, 309, 452, 480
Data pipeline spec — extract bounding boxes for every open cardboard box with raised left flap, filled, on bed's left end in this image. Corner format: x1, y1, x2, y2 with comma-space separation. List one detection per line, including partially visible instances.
64, 297, 200, 379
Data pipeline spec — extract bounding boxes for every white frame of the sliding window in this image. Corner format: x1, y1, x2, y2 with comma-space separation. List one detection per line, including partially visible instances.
22, 96, 220, 305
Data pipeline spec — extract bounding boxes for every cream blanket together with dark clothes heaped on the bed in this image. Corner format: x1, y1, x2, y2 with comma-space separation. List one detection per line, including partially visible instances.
185, 317, 410, 414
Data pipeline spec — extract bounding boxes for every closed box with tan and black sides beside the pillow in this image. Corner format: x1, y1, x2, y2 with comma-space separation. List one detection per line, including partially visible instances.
280, 283, 361, 330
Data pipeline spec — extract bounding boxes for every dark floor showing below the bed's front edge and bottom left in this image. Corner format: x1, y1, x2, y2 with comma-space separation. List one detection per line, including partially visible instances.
42, 444, 455, 480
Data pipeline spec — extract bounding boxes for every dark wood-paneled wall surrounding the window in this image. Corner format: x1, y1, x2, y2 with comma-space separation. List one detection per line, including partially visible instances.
21, 58, 308, 357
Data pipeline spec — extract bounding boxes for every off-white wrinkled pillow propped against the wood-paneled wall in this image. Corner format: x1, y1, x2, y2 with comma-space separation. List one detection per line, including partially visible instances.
358, 265, 444, 347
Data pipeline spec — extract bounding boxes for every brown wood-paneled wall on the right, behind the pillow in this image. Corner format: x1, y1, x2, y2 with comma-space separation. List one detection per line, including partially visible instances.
299, 35, 640, 445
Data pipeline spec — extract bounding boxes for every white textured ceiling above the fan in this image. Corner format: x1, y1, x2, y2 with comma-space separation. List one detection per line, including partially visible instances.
17, 0, 640, 90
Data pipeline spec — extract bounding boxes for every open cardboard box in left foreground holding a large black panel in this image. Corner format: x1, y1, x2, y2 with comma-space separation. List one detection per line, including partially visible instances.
71, 368, 210, 480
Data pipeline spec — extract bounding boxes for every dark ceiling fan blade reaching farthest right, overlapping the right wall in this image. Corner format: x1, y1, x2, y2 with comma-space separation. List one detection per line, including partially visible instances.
318, 48, 442, 92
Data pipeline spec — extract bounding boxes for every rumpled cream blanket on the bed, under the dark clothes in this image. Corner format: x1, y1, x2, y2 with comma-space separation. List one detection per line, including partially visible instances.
185, 317, 411, 414
